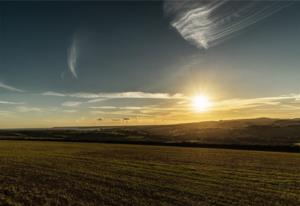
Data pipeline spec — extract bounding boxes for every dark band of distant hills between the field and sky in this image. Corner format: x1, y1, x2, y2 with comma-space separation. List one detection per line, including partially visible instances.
0, 118, 300, 146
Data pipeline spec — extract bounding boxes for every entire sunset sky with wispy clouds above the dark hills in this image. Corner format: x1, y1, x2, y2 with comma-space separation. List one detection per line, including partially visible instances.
0, 0, 300, 128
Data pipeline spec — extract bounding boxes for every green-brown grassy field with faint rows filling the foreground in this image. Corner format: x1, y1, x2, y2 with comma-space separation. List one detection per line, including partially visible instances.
0, 140, 300, 206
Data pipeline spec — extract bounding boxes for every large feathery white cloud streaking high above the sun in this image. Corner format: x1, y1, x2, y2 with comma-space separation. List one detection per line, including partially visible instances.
164, 0, 290, 49
